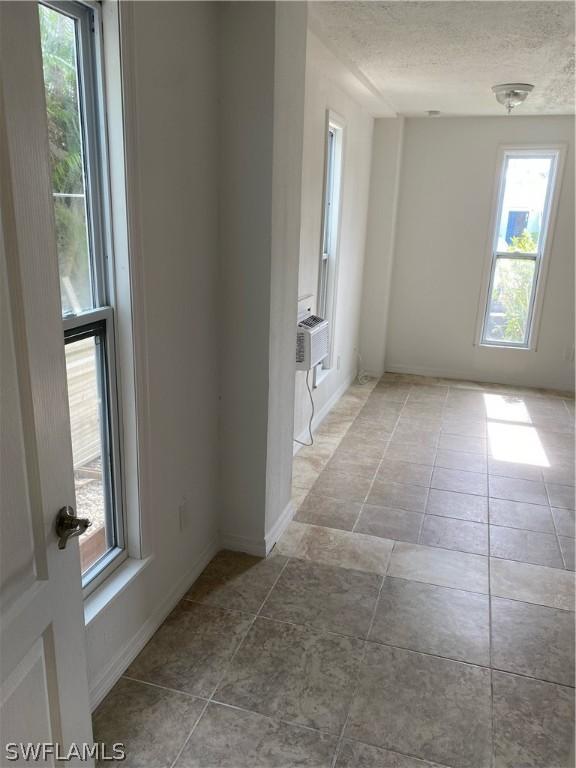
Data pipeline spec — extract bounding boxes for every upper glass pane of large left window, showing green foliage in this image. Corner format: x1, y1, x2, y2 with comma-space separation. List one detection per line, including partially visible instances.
39, 5, 93, 315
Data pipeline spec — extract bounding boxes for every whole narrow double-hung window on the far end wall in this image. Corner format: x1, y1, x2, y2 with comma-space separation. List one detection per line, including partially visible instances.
481, 149, 560, 349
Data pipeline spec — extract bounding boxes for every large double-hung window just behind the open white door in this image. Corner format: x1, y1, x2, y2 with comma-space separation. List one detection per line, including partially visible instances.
39, 2, 124, 585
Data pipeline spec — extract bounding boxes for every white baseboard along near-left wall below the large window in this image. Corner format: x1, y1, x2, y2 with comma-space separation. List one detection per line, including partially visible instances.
90, 539, 221, 710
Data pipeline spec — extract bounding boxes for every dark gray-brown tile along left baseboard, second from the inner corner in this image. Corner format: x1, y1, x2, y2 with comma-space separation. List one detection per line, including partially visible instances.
126, 600, 253, 697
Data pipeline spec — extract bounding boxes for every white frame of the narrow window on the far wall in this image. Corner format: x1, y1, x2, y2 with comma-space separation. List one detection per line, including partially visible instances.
476, 143, 566, 352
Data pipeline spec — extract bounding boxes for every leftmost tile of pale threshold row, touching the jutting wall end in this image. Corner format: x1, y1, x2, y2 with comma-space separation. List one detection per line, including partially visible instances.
280, 523, 394, 574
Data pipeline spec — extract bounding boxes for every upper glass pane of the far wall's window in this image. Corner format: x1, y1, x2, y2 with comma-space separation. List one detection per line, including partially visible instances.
496, 157, 552, 253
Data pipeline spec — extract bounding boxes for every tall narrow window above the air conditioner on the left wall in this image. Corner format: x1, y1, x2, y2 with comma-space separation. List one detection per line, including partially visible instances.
315, 113, 343, 383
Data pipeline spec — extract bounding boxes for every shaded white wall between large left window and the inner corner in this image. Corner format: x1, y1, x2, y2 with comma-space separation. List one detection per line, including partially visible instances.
86, 2, 218, 701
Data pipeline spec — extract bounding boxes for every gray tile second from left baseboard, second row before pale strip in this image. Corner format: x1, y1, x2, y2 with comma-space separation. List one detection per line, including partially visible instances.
215, 619, 364, 734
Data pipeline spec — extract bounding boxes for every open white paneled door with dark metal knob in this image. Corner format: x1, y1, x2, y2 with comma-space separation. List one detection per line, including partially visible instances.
0, 2, 92, 767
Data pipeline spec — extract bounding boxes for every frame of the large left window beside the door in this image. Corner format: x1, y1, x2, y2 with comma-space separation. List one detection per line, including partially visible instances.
38, 0, 128, 598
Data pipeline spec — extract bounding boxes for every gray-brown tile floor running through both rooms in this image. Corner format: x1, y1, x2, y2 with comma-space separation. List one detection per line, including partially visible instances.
94, 374, 574, 768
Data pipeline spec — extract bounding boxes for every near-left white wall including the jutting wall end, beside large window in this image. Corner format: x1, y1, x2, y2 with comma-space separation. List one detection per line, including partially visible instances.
85, 2, 307, 704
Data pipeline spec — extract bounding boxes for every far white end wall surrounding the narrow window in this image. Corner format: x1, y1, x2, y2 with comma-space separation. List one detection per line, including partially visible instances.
364, 116, 574, 390
